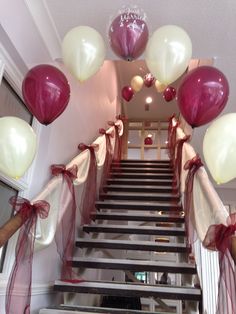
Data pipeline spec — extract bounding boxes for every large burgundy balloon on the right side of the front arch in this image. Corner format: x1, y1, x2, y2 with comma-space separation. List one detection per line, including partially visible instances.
177, 66, 229, 128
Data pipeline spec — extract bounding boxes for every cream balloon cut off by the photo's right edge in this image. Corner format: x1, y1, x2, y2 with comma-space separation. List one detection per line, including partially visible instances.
203, 113, 236, 184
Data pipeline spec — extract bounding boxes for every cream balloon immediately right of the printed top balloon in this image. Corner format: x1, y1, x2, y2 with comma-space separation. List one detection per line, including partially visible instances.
145, 25, 192, 85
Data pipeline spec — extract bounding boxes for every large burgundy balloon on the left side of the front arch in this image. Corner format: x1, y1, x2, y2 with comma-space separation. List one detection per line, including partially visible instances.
22, 64, 70, 125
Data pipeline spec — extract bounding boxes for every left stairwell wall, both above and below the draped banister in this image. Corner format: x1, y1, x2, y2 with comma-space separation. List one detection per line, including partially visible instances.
0, 61, 119, 314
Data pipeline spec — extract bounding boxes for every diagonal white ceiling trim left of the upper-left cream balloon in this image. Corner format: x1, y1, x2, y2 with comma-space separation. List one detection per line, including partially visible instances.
24, 0, 61, 60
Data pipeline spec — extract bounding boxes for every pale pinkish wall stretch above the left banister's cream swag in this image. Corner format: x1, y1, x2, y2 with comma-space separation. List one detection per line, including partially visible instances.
29, 61, 119, 198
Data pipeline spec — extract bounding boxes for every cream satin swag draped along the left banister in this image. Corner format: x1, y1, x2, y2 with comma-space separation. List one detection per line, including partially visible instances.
32, 120, 123, 251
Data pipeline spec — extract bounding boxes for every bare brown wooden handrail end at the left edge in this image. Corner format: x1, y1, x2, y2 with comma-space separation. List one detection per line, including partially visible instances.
0, 213, 24, 247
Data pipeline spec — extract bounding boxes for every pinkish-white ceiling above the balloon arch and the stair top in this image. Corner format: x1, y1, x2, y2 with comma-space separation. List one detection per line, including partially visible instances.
0, 0, 236, 120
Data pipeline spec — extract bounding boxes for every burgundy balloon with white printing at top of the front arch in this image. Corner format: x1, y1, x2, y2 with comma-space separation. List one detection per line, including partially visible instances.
109, 12, 148, 61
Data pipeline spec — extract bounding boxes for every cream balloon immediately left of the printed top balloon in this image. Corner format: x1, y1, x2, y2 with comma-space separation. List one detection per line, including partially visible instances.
62, 26, 106, 82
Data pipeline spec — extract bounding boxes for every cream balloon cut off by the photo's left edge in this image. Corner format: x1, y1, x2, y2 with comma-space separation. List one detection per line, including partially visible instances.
0, 117, 36, 179
